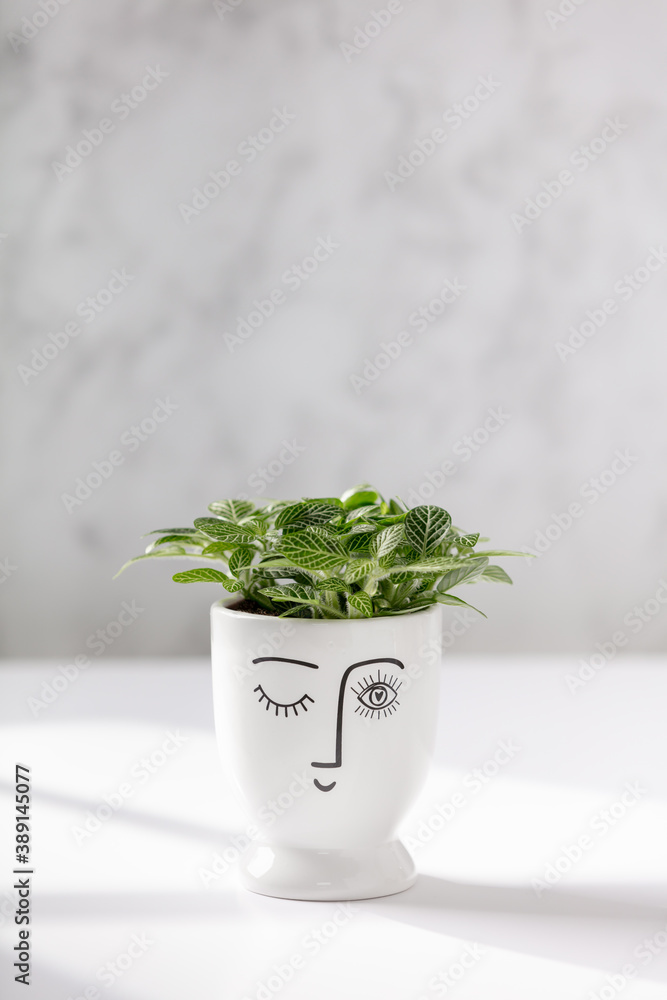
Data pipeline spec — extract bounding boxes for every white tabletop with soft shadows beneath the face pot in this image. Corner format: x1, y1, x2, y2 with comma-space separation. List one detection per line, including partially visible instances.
0, 657, 667, 1000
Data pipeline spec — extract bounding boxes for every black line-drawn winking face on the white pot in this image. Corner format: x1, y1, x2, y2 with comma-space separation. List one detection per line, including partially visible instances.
252, 656, 405, 792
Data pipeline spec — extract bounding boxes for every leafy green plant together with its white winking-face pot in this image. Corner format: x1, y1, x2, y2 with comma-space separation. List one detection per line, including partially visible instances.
123, 485, 520, 900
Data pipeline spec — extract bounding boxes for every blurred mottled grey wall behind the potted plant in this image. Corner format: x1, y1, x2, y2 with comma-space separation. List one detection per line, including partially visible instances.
0, 0, 667, 662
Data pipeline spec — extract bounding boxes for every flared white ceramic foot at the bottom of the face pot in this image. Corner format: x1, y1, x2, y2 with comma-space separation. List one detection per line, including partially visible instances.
241, 840, 417, 900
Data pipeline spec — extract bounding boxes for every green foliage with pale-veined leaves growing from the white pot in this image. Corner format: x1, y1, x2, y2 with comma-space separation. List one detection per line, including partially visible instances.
120, 485, 522, 618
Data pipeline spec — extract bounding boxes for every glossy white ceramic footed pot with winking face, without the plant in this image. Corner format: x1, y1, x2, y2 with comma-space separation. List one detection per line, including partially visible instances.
211, 602, 441, 900
